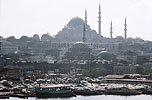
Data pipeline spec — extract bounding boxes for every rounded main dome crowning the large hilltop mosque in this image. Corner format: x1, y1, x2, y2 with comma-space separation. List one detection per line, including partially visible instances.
68, 17, 84, 27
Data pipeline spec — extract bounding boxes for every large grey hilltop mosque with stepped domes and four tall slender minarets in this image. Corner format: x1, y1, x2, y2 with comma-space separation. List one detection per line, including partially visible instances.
55, 4, 127, 43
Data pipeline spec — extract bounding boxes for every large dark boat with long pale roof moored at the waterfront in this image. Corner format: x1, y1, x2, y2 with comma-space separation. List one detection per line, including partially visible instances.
35, 84, 76, 98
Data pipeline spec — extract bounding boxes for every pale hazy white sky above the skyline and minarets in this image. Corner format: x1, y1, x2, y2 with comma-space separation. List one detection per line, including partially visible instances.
0, 0, 152, 40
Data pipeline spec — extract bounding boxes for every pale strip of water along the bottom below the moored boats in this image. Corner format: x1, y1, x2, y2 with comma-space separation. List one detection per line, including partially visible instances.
5, 95, 152, 100
